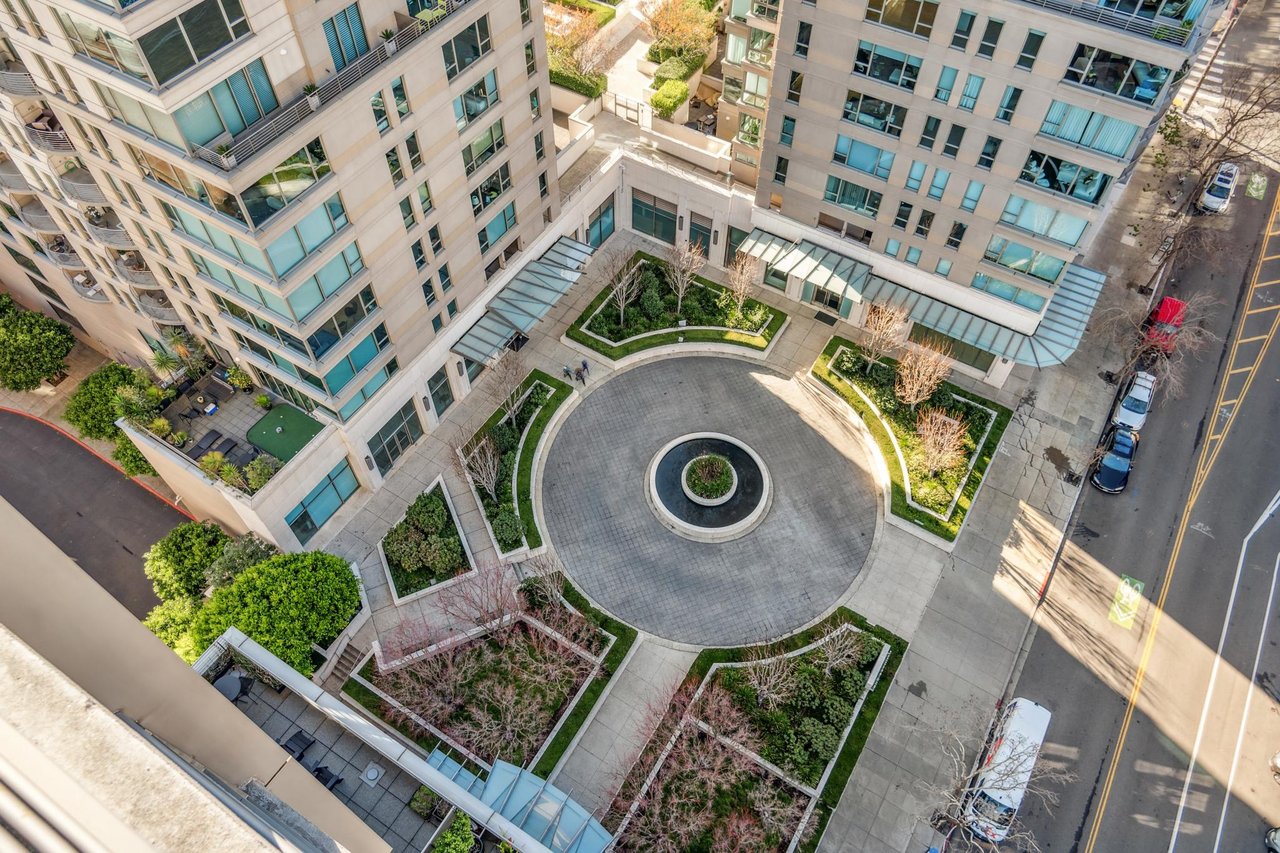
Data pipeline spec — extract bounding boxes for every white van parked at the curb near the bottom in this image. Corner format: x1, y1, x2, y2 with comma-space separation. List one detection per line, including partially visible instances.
965, 699, 1051, 841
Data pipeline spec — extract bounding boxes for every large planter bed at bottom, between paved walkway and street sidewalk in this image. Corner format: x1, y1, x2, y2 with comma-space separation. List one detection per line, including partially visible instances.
611, 608, 906, 852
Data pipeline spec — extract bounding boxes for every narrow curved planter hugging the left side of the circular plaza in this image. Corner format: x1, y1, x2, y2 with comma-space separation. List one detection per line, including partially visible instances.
467, 370, 573, 558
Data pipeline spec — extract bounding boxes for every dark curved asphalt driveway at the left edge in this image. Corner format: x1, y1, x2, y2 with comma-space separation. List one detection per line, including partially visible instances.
0, 411, 189, 619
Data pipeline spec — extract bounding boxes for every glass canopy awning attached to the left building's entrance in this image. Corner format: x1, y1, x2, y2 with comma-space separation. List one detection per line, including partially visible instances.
452, 237, 595, 364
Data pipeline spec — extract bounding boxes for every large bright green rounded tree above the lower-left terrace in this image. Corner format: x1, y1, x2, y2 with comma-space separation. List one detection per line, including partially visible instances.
191, 551, 360, 675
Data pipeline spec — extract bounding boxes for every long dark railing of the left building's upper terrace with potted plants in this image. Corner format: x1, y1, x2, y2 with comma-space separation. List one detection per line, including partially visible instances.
193, 0, 481, 172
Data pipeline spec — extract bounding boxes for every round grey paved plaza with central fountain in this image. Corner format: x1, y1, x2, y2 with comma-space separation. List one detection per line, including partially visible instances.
541, 356, 881, 646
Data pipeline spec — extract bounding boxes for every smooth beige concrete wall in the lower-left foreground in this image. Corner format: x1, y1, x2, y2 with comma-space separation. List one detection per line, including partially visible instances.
0, 501, 388, 853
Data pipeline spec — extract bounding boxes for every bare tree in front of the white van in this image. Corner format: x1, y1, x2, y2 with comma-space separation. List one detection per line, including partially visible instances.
916, 712, 1075, 853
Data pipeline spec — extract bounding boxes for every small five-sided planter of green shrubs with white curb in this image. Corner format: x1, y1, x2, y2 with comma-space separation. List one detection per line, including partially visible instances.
378, 476, 475, 605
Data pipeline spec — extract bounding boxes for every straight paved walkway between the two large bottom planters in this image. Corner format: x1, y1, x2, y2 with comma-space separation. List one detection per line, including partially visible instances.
550, 634, 698, 813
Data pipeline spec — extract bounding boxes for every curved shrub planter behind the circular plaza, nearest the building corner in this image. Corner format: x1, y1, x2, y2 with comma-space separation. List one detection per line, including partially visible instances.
568, 252, 787, 360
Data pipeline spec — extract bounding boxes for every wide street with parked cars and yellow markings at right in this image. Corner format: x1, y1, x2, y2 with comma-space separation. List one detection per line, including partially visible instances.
1014, 134, 1280, 850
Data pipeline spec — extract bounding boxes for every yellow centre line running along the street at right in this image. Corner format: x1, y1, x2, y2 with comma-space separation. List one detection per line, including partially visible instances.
1084, 183, 1280, 853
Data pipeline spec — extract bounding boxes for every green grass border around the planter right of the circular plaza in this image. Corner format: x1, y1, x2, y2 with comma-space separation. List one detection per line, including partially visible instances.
813, 336, 1012, 542
